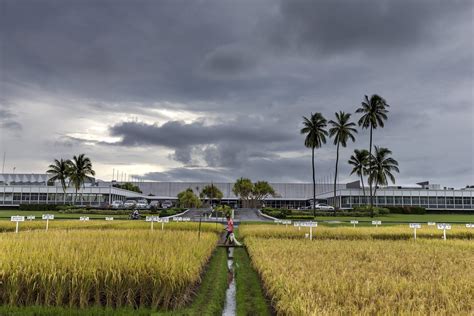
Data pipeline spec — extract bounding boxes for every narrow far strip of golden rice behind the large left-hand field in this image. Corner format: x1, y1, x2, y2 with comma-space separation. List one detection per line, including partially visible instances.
0, 219, 222, 233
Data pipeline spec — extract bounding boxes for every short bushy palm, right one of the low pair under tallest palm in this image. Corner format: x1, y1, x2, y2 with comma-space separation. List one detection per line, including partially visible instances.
369, 146, 400, 200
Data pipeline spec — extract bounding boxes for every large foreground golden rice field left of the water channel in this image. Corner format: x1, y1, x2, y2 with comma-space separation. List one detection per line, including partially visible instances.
0, 228, 218, 308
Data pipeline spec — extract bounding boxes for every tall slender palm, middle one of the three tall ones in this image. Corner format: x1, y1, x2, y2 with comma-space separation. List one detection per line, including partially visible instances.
329, 111, 357, 215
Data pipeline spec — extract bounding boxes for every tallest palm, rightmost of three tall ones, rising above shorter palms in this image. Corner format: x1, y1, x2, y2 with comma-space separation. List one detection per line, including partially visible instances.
356, 94, 389, 206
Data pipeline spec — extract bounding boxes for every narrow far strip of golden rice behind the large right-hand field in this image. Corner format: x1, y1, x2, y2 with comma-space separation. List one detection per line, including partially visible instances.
239, 224, 474, 240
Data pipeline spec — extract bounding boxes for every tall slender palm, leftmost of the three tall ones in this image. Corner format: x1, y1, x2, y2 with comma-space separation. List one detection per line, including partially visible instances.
300, 113, 328, 216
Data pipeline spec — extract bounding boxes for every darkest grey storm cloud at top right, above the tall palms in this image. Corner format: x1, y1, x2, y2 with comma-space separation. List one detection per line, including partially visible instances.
269, 0, 472, 55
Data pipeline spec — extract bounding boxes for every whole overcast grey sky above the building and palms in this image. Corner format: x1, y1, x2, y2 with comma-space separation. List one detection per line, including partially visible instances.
0, 0, 474, 187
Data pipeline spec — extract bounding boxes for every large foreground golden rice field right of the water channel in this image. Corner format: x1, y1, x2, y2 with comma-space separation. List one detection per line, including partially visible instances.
246, 238, 474, 315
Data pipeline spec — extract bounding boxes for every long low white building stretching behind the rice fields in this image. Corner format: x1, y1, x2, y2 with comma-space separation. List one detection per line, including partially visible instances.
0, 174, 474, 211
